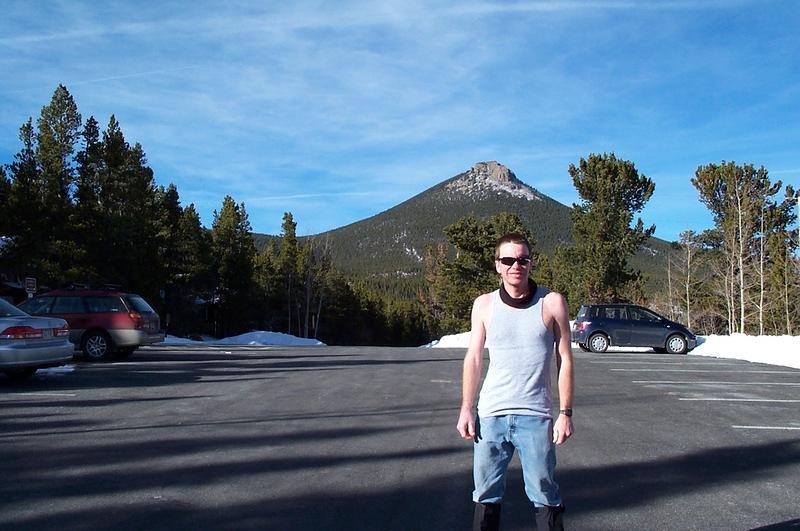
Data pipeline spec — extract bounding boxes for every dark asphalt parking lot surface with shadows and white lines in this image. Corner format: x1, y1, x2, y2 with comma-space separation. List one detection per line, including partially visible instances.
0, 346, 800, 531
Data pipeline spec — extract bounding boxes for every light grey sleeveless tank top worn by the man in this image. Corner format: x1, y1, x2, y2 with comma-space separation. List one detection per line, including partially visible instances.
478, 287, 555, 418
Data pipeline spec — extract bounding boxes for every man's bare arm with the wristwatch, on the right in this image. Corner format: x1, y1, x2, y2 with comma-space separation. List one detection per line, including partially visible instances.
547, 292, 575, 444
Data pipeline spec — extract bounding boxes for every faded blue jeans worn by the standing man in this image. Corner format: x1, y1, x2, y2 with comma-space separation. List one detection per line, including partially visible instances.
472, 415, 561, 507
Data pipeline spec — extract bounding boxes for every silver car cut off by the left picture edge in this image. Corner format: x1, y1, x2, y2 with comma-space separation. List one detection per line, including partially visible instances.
0, 299, 73, 380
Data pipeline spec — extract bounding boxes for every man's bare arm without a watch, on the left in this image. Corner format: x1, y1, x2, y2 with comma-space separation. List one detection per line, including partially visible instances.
456, 295, 491, 440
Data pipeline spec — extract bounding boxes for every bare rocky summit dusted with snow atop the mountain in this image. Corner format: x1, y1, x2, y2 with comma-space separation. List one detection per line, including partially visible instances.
445, 160, 541, 201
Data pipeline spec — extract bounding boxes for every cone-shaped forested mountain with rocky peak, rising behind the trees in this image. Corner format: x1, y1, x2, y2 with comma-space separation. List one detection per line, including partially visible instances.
256, 161, 668, 294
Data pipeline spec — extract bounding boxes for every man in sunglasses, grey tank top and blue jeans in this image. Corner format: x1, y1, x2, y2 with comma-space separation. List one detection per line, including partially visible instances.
457, 234, 573, 531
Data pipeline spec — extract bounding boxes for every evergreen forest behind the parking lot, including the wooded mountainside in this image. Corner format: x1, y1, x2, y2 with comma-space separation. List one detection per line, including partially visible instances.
0, 85, 800, 346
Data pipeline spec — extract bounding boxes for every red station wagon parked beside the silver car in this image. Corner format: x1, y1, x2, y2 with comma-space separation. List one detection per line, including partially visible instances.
19, 289, 164, 360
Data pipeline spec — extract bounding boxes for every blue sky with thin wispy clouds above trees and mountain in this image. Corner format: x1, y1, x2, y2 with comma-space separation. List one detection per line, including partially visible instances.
0, 0, 800, 240
